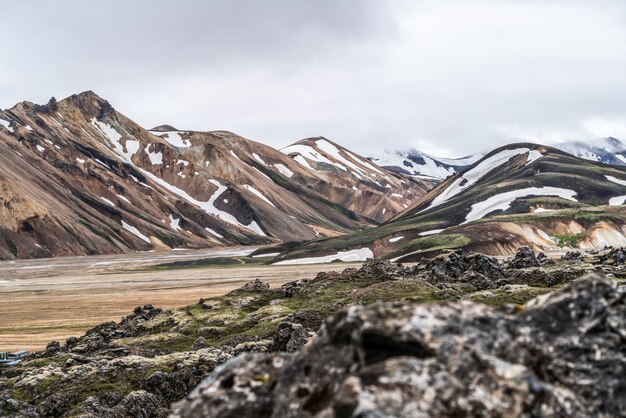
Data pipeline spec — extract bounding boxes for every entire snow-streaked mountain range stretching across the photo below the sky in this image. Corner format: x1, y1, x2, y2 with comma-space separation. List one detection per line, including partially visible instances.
6, 92, 626, 263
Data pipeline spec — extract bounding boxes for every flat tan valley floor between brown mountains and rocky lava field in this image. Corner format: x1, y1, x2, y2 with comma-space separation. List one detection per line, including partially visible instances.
0, 248, 360, 351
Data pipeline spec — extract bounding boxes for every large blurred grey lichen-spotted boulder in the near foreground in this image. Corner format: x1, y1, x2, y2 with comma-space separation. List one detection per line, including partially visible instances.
172, 275, 626, 417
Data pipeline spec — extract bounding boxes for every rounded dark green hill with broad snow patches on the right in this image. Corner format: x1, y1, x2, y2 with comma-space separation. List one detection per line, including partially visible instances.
276, 143, 626, 264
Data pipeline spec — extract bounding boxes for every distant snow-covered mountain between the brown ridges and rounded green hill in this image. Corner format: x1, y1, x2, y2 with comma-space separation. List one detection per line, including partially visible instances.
371, 149, 484, 180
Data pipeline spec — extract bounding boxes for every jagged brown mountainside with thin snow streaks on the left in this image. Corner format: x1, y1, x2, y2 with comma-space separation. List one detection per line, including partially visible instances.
0, 92, 430, 259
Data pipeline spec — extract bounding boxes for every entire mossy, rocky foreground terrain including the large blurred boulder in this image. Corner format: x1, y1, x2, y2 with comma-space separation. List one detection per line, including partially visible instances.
0, 248, 626, 417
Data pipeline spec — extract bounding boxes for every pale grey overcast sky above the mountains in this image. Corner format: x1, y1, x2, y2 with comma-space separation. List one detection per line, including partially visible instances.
0, 0, 626, 157
